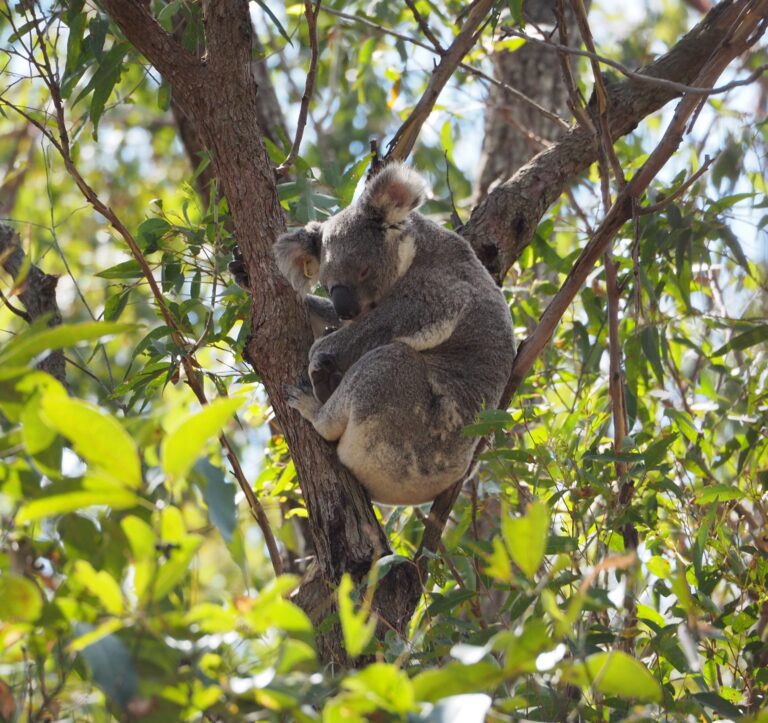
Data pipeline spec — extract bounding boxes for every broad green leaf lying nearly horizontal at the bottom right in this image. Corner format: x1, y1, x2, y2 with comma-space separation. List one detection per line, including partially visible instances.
563, 650, 662, 703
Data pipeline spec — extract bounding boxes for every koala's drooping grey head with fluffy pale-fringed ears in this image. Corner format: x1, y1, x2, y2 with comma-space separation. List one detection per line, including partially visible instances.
274, 164, 426, 319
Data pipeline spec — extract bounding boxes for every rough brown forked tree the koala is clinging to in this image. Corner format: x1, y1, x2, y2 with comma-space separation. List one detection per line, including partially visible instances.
104, 0, 768, 663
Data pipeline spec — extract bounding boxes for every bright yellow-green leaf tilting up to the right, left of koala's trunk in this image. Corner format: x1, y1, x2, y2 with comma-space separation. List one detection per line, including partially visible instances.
160, 397, 245, 477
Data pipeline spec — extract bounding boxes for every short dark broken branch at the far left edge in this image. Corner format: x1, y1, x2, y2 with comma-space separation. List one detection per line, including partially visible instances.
0, 223, 66, 384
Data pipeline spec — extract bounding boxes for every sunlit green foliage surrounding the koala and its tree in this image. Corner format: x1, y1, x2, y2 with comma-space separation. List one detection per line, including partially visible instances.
0, 0, 768, 721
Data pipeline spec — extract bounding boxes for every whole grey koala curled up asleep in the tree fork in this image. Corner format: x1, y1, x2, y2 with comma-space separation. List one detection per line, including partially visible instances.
274, 164, 515, 505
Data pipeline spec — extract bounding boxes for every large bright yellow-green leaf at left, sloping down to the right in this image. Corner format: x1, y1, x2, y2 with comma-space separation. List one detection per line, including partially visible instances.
41, 393, 142, 489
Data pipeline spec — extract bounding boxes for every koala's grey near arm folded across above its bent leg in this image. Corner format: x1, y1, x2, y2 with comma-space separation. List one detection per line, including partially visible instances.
310, 276, 468, 372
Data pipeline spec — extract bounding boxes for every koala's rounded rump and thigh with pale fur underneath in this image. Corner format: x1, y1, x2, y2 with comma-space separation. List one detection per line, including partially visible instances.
334, 342, 477, 504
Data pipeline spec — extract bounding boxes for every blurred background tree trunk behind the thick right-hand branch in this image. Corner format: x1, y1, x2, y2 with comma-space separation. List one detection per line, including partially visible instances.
474, 0, 578, 200
